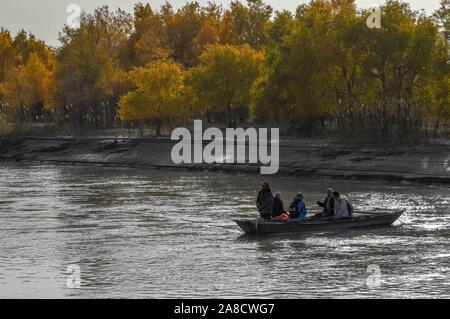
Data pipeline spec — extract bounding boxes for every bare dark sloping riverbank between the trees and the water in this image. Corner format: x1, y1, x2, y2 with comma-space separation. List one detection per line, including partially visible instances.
0, 137, 450, 184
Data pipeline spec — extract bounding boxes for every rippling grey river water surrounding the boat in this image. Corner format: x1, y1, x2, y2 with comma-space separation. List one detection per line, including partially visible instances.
0, 164, 450, 298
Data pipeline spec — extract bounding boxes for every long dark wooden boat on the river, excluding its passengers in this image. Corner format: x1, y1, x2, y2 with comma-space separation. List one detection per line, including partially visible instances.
235, 210, 405, 235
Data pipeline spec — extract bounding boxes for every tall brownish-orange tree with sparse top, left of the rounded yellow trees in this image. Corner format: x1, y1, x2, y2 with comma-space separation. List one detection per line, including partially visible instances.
56, 7, 132, 128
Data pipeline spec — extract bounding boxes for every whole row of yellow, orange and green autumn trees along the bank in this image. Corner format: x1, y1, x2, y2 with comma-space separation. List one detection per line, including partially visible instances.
0, 0, 450, 136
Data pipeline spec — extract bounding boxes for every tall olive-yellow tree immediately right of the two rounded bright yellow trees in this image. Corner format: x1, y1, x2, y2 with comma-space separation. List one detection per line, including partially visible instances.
253, 1, 335, 131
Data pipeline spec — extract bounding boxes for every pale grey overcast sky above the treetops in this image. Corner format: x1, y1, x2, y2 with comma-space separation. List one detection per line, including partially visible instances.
0, 0, 439, 45
